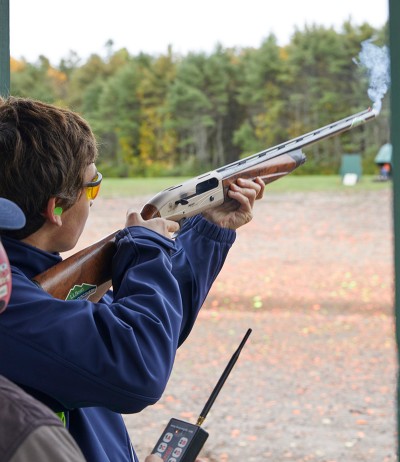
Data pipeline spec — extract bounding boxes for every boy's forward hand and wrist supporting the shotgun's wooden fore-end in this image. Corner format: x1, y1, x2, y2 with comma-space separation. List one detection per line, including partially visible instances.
203, 178, 265, 229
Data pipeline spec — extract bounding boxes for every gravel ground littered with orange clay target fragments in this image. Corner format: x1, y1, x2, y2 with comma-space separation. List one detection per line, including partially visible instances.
70, 189, 397, 462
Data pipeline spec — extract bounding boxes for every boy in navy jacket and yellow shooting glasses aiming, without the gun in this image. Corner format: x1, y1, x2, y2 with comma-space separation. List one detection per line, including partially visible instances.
0, 97, 264, 462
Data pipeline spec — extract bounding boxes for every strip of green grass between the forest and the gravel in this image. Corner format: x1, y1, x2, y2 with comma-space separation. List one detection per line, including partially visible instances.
101, 175, 392, 197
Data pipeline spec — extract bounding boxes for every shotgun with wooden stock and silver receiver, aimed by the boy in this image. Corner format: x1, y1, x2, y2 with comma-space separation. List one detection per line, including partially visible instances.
33, 108, 378, 301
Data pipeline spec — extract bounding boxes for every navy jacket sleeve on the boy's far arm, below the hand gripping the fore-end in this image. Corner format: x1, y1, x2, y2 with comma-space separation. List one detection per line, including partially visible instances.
172, 215, 236, 344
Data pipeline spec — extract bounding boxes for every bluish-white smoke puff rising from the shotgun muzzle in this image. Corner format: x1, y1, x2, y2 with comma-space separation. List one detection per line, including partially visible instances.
354, 40, 390, 113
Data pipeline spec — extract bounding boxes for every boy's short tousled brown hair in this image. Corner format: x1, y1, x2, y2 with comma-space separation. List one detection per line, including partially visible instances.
0, 97, 98, 239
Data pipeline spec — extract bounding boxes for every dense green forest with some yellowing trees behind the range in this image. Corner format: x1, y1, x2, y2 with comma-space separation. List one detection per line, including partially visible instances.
11, 21, 390, 177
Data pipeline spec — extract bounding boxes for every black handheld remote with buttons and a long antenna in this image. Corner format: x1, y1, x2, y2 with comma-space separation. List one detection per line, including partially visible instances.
152, 329, 251, 462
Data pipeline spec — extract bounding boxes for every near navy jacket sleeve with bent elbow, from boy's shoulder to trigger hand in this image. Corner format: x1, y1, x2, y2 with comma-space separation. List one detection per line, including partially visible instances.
0, 227, 182, 413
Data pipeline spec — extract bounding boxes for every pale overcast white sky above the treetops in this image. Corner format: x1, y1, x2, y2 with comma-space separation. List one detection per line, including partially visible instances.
10, 0, 388, 65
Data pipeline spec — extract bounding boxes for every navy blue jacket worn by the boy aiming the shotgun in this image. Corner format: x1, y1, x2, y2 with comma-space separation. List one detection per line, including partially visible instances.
0, 216, 235, 462
